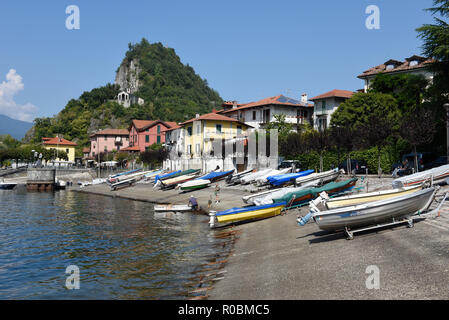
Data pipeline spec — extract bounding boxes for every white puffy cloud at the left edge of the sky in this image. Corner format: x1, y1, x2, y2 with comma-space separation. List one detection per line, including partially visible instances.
0, 69, 37, 121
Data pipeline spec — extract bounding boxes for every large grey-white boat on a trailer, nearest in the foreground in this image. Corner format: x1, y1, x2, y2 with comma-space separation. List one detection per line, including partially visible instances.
314, 188, 435, 230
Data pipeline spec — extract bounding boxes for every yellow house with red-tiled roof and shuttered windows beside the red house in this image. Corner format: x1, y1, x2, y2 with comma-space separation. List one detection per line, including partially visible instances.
181, 113, 251, 158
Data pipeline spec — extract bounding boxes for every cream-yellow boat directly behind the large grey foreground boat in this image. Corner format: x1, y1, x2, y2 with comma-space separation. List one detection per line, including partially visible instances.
325, 185, 422, 210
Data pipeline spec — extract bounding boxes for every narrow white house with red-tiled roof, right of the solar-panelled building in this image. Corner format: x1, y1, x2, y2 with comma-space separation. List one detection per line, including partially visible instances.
310, 89, 354, 130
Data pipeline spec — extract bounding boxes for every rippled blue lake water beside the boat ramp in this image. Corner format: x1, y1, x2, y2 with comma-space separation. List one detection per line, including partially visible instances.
0, 188, 228, 299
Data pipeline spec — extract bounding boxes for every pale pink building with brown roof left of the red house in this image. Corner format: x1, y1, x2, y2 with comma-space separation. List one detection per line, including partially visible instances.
89, 129, 129, 158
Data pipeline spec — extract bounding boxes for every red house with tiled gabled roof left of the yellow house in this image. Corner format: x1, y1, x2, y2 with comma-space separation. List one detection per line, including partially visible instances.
128, 120, 177, 152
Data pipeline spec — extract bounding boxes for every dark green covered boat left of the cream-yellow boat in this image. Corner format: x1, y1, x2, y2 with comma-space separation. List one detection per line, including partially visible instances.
273, 178, 358, 209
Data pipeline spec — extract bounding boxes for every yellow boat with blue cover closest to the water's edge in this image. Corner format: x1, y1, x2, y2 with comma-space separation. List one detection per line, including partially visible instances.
215, 202, 287, 223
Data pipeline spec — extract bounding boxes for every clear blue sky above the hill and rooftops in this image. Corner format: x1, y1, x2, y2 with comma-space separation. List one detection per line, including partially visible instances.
0, 0, 432, 120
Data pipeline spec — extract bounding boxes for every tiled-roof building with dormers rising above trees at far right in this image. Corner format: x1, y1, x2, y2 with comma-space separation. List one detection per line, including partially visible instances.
357, 55, 435, 92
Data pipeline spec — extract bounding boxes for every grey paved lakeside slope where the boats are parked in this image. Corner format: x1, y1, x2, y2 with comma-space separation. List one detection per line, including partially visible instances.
71, 176, 449, 300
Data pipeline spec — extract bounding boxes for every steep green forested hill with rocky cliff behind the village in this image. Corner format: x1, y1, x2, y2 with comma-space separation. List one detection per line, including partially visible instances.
24, 39, 222, 154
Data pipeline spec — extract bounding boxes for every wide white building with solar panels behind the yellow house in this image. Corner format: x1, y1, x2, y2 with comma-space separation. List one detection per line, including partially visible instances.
218, 93, 313, 131
